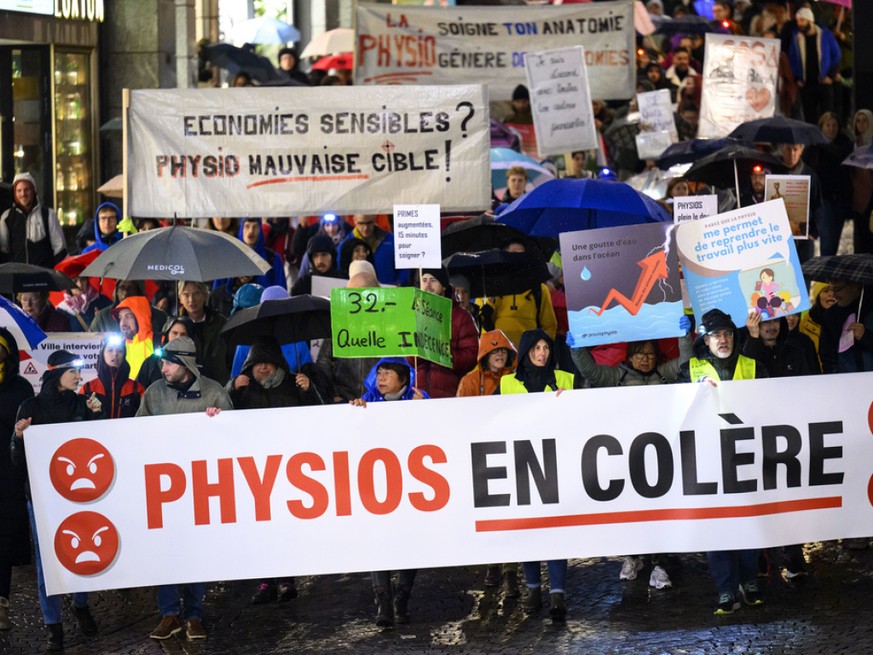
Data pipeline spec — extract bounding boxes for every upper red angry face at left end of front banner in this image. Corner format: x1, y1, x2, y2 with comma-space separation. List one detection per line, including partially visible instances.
49, 439, 115, 503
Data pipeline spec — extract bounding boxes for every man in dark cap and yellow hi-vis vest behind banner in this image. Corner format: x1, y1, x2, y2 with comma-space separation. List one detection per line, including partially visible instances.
679, 309, 767, 615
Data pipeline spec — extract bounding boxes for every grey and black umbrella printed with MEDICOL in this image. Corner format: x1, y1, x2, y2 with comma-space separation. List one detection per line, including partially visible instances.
82, 225, 270, 282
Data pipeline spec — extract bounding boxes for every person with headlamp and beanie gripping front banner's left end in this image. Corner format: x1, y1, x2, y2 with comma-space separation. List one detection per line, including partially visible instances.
10, 350, 103, 651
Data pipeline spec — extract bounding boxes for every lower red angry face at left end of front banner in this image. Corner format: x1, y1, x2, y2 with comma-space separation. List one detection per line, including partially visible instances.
55, 512, 118, 575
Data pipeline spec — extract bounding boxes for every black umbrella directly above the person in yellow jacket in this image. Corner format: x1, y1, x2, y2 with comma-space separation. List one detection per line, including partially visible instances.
443, 249, 552, 298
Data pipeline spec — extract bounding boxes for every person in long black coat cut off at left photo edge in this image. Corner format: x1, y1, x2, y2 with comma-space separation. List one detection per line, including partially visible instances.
0, 327, 33, 630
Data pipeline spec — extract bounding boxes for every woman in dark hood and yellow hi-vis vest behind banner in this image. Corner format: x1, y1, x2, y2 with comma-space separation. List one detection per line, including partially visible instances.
500, 328, 574, 623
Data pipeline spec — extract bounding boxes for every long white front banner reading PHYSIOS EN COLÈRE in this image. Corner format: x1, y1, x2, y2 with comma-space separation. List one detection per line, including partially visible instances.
24, 373, 873, 594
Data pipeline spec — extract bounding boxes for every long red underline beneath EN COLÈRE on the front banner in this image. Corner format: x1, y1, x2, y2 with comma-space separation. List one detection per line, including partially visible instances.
476, 496, 843, 532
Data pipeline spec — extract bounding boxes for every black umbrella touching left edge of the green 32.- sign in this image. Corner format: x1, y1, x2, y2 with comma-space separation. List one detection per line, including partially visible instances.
221, 294, 330, 346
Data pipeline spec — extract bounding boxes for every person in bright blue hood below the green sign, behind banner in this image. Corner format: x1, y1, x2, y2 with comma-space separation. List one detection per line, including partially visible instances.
349, 357, 428, 628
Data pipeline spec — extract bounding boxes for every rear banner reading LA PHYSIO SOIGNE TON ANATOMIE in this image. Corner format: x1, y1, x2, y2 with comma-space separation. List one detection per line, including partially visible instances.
355, 0, 636, 100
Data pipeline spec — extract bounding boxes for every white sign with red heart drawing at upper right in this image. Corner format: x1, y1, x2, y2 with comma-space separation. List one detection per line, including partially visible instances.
698, 34, 779, 139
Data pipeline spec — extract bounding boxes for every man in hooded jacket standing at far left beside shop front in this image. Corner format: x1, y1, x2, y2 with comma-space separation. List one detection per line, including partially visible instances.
0, 173, 67, 268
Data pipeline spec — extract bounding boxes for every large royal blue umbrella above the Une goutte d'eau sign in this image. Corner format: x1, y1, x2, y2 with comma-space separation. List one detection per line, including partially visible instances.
498, 178, 671, 238
